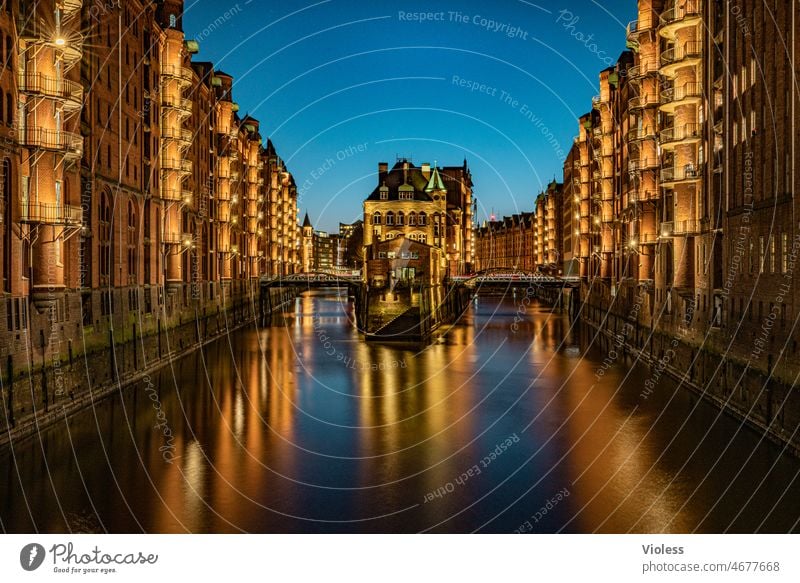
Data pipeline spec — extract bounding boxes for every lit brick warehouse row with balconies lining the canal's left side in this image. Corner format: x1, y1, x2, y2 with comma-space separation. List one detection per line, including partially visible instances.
0, 0, 299, 428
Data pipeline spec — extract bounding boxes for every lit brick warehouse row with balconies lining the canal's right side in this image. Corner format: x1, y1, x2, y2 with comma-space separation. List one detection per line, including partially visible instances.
561, 0, 800, 442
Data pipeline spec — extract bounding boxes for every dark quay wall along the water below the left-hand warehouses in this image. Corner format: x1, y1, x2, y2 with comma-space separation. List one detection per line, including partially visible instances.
0, 286, 296, 448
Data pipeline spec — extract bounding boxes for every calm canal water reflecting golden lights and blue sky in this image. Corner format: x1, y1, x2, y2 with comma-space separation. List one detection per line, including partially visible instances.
0, 292, 800, 532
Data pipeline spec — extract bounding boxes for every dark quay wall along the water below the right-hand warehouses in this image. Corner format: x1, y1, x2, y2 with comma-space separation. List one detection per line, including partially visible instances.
564, 289, 800, 457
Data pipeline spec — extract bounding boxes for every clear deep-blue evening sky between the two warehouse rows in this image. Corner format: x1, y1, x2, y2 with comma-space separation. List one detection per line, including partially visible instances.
184, 0, 636, 232
